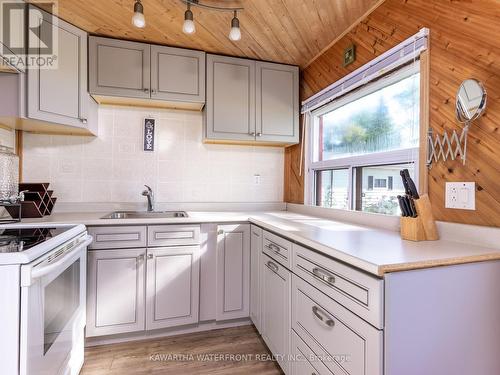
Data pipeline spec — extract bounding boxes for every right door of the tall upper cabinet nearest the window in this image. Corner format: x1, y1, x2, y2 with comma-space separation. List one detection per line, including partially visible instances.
256, 62, 299, 143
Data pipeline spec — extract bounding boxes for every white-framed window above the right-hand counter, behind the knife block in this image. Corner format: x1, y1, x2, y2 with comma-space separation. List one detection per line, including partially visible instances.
309, 64, 420, 215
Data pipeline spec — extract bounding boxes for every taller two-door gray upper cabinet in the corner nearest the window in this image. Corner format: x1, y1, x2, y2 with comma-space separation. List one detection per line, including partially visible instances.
205, 55, 299, 145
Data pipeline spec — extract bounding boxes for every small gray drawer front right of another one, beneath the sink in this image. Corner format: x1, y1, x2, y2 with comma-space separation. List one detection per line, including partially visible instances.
148, 225, 200, 246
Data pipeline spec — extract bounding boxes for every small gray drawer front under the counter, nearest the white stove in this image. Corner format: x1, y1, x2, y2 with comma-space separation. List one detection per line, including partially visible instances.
88, 226, 146, 249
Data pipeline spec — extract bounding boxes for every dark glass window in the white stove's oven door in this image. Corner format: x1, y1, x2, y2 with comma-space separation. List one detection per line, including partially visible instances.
43, 259, 80, 355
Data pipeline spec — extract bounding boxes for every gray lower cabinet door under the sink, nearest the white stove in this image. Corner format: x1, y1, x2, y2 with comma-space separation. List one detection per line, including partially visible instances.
86, 249, 146, 337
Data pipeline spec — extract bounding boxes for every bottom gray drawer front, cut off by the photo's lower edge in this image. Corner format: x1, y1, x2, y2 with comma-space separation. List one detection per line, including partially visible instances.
291, 330, 335, 375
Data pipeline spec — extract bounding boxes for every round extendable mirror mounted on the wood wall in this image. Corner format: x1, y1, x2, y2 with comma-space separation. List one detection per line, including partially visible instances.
456, 79, 486, 123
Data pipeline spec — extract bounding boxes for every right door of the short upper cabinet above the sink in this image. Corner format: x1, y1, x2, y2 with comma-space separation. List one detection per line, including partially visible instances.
151, 46, 205, 103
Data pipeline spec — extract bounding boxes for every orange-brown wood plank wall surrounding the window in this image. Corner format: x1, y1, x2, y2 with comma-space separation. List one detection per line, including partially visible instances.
285, 0, 500, 227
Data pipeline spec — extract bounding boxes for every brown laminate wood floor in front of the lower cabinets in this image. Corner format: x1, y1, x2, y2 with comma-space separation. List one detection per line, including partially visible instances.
80, 326, 283, 375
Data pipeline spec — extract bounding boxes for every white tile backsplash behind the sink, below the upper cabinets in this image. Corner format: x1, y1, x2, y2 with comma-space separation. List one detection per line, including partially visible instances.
23, 106, 284, 203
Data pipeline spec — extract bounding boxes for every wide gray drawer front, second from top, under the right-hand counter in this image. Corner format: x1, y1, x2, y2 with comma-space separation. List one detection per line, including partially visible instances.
292, 276, 383, 375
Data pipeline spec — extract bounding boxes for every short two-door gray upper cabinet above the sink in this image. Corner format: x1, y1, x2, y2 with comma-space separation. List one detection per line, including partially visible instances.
89, 37, 205, 109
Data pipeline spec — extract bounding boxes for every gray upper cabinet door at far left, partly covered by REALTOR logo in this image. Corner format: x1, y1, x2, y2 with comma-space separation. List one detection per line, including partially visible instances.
27, 10, 90, 128
